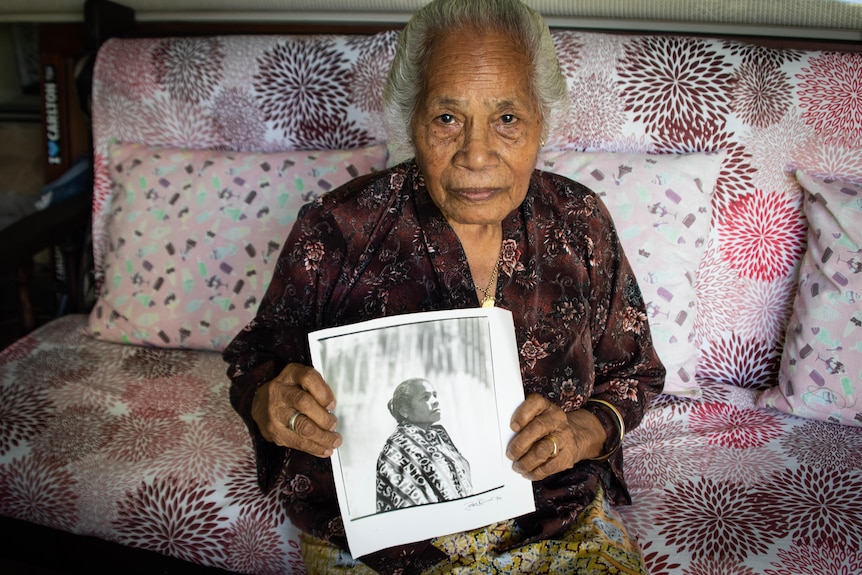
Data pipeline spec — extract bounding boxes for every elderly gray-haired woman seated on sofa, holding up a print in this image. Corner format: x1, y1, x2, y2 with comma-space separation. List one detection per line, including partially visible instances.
225, 0, 664, 573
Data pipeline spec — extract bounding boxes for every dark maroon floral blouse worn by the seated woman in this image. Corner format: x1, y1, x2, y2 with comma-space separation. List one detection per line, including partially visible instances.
224, 161, 665, 572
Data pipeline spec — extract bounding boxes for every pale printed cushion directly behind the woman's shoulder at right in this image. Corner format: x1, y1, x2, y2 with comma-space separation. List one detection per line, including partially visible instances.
538, 151, 724, 397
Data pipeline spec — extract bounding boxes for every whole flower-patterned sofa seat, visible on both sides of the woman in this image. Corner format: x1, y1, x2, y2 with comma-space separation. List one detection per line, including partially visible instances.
0, 315, 862, 575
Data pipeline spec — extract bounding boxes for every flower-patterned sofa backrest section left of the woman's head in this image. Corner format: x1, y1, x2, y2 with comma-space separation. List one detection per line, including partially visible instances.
92, 32, 397, 272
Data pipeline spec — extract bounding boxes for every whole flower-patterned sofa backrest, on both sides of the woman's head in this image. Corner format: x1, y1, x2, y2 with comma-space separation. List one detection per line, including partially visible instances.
92, 30, 862, 387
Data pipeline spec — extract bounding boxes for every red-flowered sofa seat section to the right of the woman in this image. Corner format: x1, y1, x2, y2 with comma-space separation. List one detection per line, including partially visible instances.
619, 382, 862, 575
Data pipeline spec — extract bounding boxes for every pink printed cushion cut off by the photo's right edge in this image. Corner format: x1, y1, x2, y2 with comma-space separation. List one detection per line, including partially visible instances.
757, 172, 862, 426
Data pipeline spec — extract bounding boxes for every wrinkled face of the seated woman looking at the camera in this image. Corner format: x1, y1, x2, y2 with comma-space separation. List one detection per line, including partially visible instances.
411, 25, 542, 231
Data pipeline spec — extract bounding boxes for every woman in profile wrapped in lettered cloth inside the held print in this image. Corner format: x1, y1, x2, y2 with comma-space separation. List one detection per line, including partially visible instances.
377, 378, 473, 513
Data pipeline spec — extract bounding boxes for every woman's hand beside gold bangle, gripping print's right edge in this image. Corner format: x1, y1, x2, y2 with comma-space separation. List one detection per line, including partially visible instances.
506, 393, 606, 481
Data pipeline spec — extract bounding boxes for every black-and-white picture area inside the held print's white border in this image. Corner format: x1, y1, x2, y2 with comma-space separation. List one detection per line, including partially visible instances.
319, 317, 508, 519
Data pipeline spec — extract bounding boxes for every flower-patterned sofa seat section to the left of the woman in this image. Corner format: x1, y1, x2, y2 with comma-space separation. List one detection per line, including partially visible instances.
0, 314, 303, 573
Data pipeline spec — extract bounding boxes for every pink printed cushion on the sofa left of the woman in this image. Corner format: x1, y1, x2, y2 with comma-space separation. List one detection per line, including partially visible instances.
90, 144, 386, 350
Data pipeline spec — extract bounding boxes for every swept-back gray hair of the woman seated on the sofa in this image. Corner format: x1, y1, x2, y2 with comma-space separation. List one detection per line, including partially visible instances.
383, 0, 569, 161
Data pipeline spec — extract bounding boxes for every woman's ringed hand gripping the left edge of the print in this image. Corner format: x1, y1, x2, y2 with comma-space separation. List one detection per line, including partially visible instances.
251, 363, 341, 457
